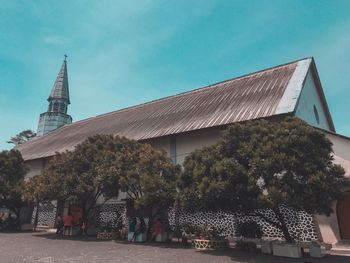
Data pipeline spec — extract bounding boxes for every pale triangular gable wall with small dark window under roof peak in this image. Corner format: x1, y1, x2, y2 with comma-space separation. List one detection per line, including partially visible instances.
295, 70, 330, 130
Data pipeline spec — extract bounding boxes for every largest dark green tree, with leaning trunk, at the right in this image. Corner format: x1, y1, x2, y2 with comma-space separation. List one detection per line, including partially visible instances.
179, 117, 350, 242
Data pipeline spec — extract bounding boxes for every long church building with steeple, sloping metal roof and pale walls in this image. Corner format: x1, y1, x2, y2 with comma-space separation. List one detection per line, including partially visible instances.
18, 58, 350, 243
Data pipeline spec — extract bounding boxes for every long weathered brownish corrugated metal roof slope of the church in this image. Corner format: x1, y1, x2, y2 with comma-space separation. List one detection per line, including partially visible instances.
18, 58, 311, 160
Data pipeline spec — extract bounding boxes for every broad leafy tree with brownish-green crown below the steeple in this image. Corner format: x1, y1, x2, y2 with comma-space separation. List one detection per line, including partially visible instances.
31, 135, 129, 225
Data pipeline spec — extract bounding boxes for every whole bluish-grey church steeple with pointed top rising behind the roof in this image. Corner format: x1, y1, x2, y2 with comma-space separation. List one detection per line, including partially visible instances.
37, 55, 72, 136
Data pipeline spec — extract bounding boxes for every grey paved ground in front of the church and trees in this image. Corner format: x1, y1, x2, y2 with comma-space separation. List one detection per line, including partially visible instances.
0, 233, 350, 263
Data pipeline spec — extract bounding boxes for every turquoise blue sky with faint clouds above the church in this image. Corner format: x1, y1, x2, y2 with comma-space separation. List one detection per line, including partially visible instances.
0, 0, 350, 150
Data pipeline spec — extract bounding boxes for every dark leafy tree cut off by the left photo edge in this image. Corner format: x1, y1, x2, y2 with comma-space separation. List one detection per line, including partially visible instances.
0, 150, 27, 223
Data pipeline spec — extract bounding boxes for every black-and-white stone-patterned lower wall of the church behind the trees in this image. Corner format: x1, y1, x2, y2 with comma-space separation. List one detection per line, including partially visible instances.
32, 203, 318, 241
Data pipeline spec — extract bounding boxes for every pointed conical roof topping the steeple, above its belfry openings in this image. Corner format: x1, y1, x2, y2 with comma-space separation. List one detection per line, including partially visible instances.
47, 55, 70, 104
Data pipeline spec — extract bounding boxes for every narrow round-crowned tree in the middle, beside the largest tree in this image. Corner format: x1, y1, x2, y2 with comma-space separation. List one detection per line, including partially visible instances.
116, 143, 181, 238
